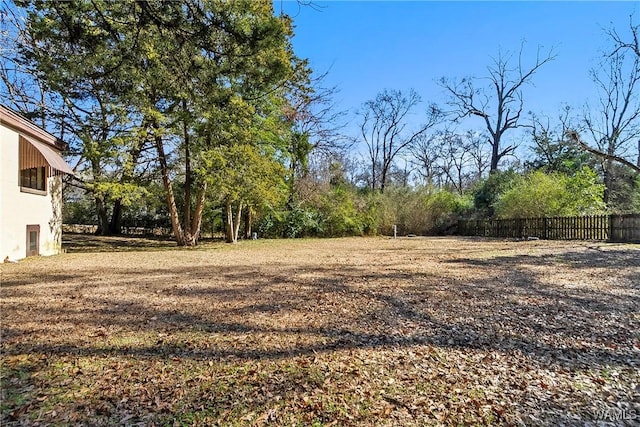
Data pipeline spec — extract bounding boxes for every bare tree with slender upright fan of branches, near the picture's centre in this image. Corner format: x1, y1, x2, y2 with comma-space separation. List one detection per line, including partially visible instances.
359, 89, 440, 192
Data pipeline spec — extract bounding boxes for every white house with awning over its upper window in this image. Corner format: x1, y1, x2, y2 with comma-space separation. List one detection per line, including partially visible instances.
0, 105, 73, 262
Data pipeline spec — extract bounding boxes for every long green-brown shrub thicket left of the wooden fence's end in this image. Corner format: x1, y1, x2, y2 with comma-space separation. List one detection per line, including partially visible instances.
256, 184, 471, 238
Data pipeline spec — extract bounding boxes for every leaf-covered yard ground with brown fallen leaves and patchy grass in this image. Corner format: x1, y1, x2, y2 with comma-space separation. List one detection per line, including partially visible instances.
0, 236, 640, 426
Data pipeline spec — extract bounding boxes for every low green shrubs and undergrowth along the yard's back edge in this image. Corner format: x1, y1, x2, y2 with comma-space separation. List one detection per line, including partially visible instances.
60, 164, 620, 239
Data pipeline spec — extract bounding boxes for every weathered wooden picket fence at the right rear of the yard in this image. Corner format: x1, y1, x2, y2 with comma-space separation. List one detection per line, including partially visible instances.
458, 214, 640, 242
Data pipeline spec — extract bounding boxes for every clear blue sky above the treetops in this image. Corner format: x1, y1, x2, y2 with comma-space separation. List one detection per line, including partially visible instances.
274, 0, 640, 135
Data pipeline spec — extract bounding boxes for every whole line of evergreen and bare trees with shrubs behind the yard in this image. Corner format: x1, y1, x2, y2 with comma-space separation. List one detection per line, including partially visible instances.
0, 0, 640, 241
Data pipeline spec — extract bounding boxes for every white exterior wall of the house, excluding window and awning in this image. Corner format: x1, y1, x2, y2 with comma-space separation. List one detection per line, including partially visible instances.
0, 126, 62, 262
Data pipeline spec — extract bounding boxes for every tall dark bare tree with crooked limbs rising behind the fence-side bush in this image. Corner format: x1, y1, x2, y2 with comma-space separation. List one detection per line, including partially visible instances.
440, 45, 555, 171
